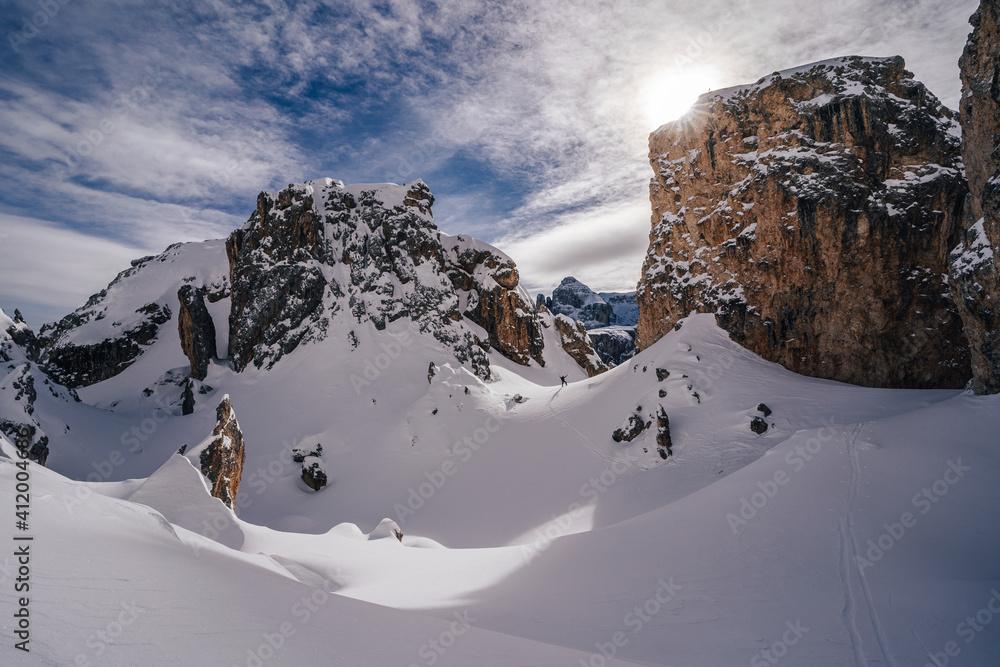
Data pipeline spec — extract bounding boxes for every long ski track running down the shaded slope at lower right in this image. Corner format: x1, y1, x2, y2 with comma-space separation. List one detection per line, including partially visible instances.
839, 423, 898, 667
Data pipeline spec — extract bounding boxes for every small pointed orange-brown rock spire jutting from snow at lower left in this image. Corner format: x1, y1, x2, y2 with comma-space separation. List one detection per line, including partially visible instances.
185, 396, 246, 509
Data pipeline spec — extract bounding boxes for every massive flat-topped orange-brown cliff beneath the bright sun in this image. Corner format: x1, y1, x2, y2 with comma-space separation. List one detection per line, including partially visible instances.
637, 57, 971, 388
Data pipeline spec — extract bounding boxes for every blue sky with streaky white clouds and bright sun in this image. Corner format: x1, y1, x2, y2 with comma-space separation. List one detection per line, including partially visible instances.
0, 0, 978, 327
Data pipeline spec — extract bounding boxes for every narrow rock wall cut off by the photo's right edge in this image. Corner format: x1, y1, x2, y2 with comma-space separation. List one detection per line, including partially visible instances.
951, 0, 1000, 394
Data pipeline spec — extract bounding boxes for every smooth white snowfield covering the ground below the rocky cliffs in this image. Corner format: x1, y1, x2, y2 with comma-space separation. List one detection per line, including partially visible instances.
0, 315, 1000, 666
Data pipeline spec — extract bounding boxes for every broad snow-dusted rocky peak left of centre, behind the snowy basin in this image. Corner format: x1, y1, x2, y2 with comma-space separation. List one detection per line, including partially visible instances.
226, 179, 584, 379
